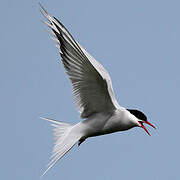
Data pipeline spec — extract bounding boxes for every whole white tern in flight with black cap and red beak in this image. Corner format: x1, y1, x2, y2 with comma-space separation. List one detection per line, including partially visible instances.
40, 4, 155, 175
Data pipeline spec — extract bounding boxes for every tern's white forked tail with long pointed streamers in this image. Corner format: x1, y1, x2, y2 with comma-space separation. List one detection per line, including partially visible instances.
41, 117, 81, 176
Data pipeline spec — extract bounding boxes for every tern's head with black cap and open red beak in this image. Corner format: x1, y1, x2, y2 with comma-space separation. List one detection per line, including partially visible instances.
127, 109, 156, 136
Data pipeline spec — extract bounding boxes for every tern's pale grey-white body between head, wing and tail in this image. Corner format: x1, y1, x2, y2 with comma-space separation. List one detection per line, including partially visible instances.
81, 108, 136, 138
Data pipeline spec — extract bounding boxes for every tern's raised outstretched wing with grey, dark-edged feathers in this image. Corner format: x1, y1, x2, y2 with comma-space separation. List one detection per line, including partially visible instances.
41, 3, 120, 118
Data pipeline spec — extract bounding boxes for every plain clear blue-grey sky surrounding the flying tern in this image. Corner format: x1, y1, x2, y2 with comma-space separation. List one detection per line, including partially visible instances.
0, 0, 180, 180
